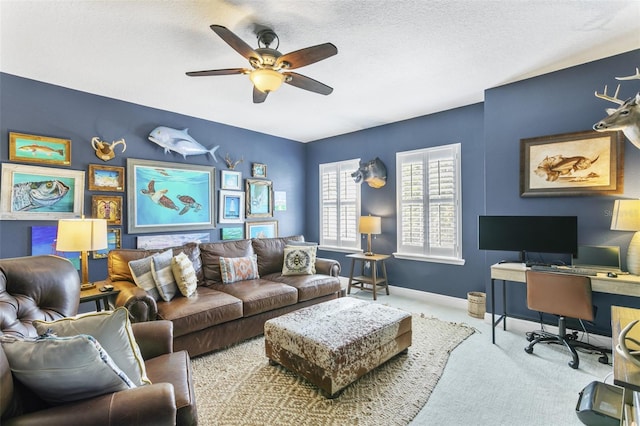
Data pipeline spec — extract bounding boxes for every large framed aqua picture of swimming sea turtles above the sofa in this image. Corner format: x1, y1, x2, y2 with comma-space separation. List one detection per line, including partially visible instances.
127, 158, 216, 234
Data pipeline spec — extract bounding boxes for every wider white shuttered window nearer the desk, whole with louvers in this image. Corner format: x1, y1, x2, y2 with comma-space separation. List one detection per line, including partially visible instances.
394, 144, 464, 264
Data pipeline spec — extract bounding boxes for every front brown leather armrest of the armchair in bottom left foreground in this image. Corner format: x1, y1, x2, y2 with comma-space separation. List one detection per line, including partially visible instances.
2, 383, 177, 426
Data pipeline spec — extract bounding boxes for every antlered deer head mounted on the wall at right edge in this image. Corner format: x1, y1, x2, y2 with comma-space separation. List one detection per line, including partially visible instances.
593, 68, 640, 149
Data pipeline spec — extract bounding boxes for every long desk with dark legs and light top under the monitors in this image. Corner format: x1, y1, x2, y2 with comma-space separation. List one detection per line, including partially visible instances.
491, 263, 640, 343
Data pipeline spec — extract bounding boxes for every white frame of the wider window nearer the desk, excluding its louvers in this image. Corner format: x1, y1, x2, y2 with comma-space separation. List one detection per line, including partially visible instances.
393, 143, 465, 265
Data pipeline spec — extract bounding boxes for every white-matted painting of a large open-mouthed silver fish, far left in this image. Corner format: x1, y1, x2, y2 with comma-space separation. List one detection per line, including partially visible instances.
0, 163, 85, 220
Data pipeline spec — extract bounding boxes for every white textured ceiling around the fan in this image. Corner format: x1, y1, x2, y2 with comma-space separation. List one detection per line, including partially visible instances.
0, 0, 640, 142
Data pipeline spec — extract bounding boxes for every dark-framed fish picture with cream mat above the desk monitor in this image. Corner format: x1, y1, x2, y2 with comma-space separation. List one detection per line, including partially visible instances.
520, 130, 624, 197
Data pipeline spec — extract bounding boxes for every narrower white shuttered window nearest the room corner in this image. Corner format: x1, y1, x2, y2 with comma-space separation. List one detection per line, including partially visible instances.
320, 159, 360, 250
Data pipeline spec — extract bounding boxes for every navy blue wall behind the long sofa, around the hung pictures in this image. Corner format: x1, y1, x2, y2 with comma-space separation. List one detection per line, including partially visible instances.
0, 73, 305, 280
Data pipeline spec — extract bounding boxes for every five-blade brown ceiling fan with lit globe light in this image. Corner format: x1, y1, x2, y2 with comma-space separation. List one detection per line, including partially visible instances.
187, 25, 338, 103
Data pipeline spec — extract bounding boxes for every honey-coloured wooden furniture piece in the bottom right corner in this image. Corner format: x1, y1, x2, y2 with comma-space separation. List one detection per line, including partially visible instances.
611, 306, 640, 425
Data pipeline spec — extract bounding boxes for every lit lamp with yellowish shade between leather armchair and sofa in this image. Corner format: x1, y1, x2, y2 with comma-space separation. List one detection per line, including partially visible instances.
56, 216, 108, 290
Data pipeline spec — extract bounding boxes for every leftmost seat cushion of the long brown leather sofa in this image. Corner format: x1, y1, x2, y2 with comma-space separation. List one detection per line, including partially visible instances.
158, 284, 242, 337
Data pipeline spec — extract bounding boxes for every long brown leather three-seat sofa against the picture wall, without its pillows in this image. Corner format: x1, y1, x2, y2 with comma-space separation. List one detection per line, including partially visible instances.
107, 236, 340, 357
